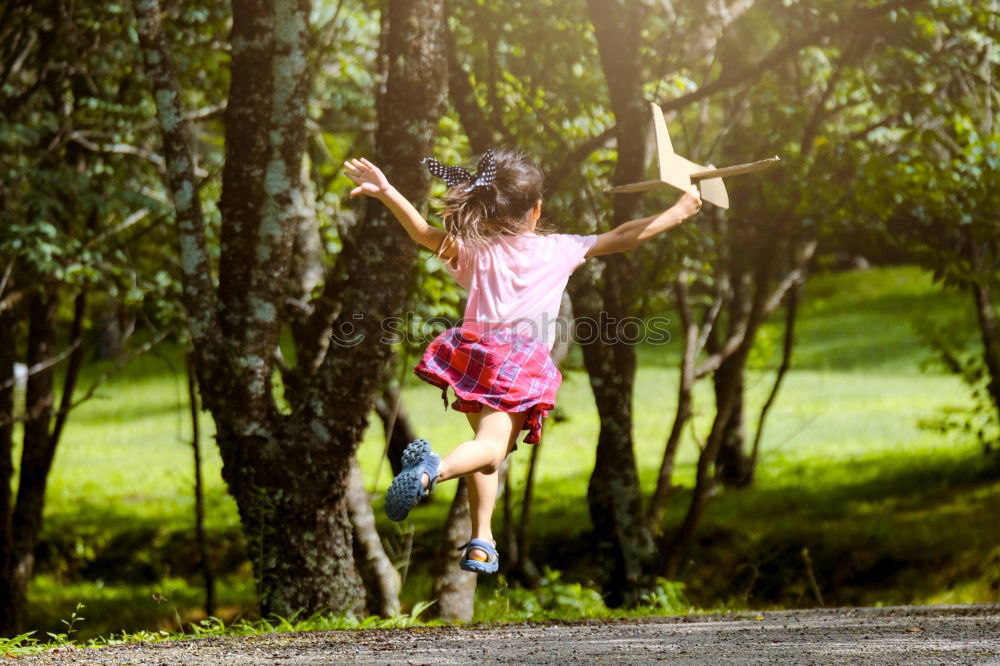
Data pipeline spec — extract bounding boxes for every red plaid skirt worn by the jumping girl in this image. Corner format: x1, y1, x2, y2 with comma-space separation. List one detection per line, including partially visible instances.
413, 324, 562, 444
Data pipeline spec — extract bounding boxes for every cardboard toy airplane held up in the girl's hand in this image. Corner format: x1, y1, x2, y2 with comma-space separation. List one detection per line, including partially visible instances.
605, 103, 780, 208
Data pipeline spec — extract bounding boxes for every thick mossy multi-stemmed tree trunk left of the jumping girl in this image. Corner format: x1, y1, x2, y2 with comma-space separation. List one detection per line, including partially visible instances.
135, 0, 445, 616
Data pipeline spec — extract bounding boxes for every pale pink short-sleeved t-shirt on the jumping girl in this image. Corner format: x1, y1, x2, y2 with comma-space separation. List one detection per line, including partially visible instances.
445, 233, 597, 349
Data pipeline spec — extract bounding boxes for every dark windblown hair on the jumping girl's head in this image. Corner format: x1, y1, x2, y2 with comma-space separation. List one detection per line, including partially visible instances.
441, 148, 543, 243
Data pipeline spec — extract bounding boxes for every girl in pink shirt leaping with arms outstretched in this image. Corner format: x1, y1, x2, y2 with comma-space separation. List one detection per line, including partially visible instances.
344, 150, 701, 573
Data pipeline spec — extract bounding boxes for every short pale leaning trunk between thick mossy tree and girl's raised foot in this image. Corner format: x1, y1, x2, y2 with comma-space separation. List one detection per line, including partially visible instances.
347, 458, 402, 617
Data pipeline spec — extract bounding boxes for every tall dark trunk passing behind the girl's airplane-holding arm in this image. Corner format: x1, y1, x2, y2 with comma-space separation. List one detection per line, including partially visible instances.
571, 0, 653, 607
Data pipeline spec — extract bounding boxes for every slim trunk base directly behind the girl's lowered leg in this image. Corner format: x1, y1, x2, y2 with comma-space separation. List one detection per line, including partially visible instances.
433, 478, 476, 622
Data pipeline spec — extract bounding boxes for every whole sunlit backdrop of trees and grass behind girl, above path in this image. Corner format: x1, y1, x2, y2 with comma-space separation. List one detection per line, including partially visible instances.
0, 0, 1000, 635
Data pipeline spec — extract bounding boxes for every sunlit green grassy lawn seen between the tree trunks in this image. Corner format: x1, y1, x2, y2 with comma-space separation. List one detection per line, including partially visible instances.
19, 268, 1000, 634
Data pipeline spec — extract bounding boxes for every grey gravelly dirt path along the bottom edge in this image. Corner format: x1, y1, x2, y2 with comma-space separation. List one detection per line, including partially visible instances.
18, 605, 1000, 665
